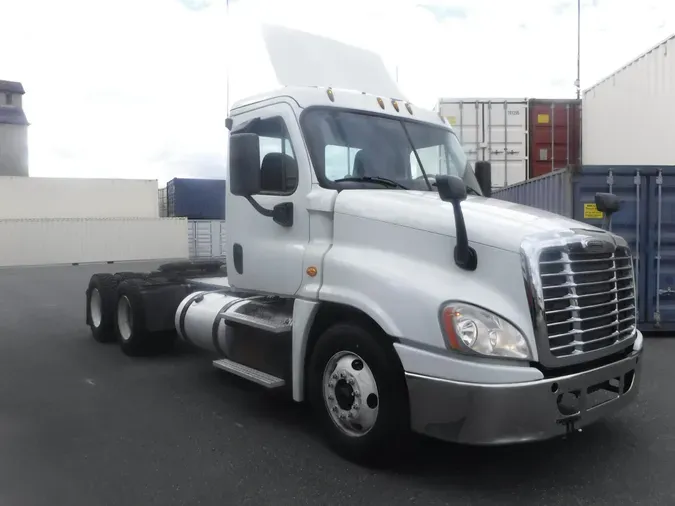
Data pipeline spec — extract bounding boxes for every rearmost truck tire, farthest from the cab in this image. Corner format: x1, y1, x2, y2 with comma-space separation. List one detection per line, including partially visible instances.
86, 274, 117, 343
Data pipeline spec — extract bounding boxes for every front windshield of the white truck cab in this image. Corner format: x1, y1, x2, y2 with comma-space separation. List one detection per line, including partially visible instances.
303, 109, 481, 194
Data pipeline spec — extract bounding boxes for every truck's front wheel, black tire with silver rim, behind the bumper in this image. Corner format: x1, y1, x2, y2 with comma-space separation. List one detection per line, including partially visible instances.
308, 323, 409, 464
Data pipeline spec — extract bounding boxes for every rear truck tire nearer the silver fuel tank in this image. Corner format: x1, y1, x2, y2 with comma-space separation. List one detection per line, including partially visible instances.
115, 279, 175, 357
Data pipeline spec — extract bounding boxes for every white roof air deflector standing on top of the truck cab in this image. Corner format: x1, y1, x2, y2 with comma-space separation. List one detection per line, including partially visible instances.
262, 25, 405, 100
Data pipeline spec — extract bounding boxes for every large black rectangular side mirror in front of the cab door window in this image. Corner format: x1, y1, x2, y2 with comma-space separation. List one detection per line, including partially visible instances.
228, 133, 260, 197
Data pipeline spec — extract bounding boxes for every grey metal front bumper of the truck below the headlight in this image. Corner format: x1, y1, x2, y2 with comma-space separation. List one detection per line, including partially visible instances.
406, 350, 642, 445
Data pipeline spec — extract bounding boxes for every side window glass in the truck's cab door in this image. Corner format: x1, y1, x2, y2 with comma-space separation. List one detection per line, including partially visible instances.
251, 116, 298, 195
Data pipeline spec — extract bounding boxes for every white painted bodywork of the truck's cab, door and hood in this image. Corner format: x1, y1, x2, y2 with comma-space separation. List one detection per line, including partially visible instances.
226, 88, 620, 400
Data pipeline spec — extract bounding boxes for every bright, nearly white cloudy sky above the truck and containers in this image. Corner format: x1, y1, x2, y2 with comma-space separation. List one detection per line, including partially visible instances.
0, 0, 675, 183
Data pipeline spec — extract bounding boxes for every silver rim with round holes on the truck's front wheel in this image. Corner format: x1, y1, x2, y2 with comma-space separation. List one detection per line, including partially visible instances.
323, 351, 380, 437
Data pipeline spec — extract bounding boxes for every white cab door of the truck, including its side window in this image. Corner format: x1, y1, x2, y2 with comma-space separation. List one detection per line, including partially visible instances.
226, 102, 311, 296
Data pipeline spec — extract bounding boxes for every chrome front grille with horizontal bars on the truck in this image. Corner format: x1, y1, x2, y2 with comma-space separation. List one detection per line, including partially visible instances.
539, 246, 636, 358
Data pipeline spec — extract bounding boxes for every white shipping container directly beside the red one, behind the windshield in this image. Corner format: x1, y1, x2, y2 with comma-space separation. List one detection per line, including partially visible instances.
438, 98, 529, 188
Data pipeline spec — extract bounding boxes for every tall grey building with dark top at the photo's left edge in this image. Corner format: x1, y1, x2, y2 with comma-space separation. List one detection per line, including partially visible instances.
0, 80, 28, 176
